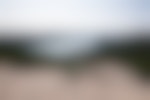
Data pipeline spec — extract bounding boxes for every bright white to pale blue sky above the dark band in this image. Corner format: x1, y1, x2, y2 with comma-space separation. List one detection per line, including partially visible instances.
0, 0, 149, 30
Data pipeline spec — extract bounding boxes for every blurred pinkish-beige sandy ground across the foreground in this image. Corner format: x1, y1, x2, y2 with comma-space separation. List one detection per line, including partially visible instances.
0, 62, 150, 100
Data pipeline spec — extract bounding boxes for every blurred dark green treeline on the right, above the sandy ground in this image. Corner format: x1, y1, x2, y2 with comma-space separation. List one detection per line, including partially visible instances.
104, 37, 150, 78
